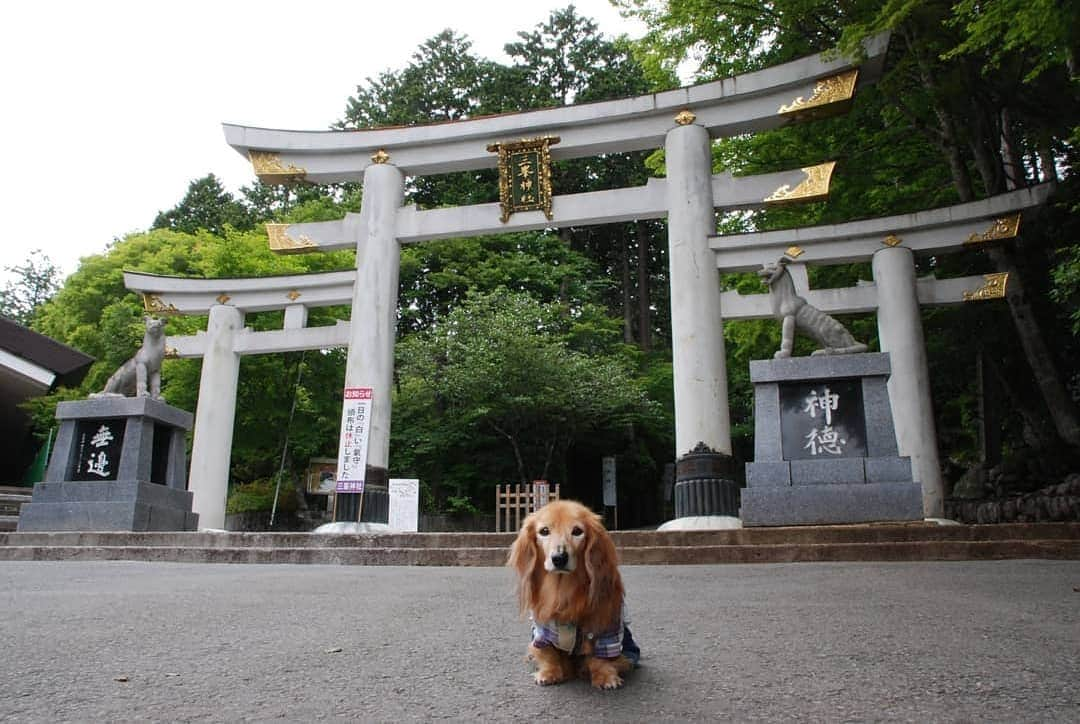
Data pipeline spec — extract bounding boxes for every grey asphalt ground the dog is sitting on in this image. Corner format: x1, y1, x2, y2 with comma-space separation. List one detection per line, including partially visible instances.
0, 561, 1080, 722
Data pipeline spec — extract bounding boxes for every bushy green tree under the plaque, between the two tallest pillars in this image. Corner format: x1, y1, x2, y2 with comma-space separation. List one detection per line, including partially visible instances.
394, 289, 653, 505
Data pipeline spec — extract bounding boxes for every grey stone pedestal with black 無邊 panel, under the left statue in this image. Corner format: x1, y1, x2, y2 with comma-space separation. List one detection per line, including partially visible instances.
18, 398, 199, 532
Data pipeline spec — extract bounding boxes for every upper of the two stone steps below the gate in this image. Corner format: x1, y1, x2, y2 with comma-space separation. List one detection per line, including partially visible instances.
0, 523, 1080, 550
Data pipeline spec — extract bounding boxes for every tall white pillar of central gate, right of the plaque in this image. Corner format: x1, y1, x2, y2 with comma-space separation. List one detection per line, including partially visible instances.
664, 124, 731, 457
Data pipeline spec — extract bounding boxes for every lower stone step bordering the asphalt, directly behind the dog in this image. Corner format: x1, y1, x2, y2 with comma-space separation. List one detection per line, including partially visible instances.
0, 539, 1080, 566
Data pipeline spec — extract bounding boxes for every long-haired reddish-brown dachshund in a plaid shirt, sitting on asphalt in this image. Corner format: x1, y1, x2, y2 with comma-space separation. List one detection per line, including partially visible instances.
508, 500, 639, 688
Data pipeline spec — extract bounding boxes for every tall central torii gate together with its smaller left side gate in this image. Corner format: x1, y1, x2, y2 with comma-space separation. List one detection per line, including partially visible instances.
127, 36, 888, 527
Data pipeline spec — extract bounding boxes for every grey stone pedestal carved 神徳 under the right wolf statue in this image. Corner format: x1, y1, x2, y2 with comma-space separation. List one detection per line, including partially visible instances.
741, 353, 923, 526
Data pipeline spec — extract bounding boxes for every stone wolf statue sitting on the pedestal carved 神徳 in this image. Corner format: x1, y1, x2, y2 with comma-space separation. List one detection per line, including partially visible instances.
757, 257, 866, 358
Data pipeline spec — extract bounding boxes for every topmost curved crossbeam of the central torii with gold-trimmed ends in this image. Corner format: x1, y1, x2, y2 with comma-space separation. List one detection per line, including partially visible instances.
224, 33, 889, 184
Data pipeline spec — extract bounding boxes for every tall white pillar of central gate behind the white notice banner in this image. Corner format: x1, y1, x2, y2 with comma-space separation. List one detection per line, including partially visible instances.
345, 163, 405, 475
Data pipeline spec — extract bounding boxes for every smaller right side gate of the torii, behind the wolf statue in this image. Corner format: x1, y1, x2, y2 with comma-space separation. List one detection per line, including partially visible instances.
710, 184, 1051, 518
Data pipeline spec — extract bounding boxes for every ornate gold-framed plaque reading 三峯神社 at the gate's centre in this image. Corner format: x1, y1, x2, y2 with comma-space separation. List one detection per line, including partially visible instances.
487, 136, 559, 224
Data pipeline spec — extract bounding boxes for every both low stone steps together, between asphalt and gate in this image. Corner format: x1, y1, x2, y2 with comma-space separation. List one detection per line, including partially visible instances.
0, 523, 1080, 566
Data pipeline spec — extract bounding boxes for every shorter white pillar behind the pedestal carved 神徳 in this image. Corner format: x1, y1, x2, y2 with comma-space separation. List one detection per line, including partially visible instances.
873, 246, 945, 518
